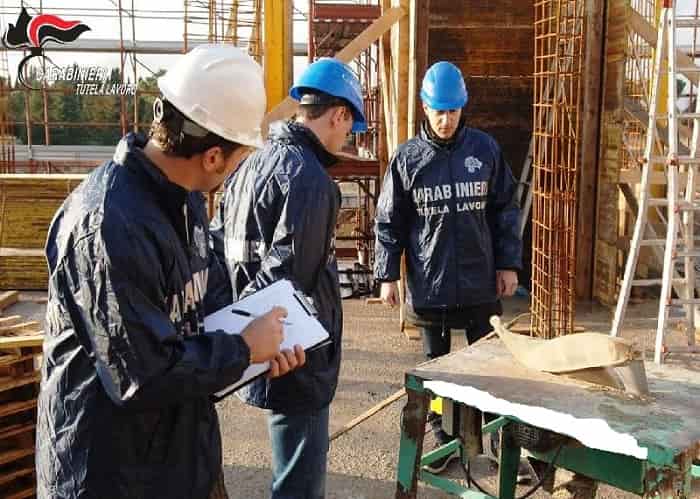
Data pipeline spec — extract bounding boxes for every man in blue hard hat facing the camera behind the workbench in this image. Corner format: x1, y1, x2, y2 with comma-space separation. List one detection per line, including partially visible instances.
375, 61, 522, 472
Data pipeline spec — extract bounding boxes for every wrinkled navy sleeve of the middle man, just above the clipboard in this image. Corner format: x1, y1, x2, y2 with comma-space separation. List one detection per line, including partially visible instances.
243, 167, 339, 295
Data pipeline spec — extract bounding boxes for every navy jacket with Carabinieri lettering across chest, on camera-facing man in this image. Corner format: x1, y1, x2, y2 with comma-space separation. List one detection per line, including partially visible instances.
375, 124, 522, 309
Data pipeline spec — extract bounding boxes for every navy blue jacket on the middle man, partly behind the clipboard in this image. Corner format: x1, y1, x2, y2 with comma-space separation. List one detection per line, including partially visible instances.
211, 122, 343, 412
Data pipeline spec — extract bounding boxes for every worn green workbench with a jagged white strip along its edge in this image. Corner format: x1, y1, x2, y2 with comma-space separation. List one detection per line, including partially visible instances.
395, 336, 700, 499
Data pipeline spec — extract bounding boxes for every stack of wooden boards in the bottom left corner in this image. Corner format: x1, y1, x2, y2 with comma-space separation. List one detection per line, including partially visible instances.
0, 291, 43, 499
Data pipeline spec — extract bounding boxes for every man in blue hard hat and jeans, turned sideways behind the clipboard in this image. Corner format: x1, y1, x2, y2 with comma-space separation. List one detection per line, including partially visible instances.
212, 58, 366, 499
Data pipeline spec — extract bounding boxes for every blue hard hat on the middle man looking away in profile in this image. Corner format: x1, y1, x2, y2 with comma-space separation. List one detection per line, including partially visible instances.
289, 57, 367, 132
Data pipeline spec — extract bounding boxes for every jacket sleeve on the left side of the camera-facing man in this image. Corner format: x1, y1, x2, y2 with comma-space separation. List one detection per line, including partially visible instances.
374, 156, 409, 282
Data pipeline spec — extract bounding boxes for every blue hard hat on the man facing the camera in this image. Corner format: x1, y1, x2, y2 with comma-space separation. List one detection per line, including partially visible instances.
420, 61, 469, 111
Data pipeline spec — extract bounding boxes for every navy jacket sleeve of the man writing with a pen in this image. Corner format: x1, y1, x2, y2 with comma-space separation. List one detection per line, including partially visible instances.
58, 225, 250, 410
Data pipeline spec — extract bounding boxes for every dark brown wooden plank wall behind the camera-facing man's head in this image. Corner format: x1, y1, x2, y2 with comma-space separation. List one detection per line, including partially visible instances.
418, 0, 534, 176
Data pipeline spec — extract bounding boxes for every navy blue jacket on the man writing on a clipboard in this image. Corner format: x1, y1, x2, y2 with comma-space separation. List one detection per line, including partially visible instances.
36, 135, 250, 499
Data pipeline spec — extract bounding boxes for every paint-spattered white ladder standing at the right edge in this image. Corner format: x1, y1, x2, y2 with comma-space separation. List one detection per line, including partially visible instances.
610, 0, 700, 364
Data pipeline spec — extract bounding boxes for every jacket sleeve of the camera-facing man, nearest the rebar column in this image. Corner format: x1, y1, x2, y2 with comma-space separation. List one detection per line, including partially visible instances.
487, 144, 522, 270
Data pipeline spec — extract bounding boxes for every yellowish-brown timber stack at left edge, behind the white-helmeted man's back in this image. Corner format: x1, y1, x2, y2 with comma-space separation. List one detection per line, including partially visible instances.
0, 174, 85, 290
